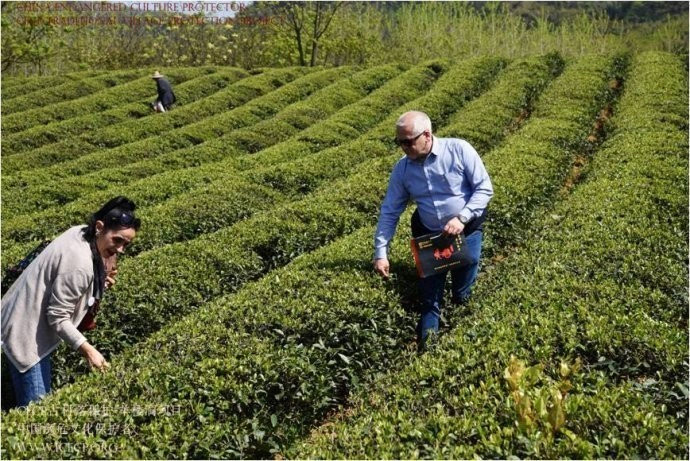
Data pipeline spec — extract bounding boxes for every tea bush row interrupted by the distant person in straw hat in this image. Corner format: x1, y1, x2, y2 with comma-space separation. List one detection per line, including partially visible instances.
2, 67, 249, 158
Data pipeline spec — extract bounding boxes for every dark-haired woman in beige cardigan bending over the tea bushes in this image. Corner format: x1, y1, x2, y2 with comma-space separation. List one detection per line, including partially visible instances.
0, 197, 140, 407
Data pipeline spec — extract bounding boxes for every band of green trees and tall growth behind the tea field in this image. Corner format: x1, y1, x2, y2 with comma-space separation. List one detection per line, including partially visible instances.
2, 2, 688, 76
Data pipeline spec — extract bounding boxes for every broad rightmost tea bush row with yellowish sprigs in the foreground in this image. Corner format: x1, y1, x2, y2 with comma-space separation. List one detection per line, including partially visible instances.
292, 52, 688, 459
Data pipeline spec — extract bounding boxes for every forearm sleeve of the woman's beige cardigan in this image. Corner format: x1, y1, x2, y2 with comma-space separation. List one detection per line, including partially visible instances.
46, 270, 91, 349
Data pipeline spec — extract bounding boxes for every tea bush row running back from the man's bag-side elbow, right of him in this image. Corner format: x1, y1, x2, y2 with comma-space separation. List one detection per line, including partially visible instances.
476, 55, 628, 255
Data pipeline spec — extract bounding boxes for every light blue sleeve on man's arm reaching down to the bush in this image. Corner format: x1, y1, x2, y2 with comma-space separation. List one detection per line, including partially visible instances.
374, 164, 410, 259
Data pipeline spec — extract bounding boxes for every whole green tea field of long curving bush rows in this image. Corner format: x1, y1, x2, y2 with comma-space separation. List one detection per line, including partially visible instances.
2, 52, 688, 458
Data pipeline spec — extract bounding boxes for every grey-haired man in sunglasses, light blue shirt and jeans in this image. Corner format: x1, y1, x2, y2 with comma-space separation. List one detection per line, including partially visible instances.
374, 111, 493, 349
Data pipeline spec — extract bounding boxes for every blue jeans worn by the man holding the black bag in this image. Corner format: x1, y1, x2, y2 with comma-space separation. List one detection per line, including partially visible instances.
412, 210, 484, 342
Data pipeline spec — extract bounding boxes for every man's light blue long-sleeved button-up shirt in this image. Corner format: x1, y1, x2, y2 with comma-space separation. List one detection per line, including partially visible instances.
374, 136, 494, 259
